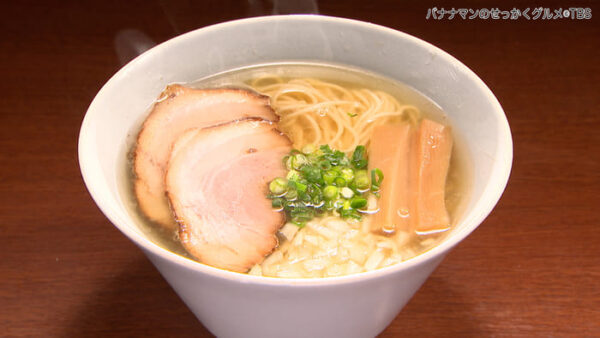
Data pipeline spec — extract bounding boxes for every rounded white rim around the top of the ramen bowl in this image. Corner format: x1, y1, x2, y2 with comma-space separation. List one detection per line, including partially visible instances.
78, 14, 513, 287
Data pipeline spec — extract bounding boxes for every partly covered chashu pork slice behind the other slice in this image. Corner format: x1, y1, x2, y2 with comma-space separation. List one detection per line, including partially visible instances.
133, 85, 279, 230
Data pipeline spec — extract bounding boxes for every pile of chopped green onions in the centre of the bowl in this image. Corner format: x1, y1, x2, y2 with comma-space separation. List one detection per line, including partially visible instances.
267, 144, 383, 227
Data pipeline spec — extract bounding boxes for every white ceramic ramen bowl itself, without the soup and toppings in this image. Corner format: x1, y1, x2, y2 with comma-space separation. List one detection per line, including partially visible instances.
79, 15, 512, 337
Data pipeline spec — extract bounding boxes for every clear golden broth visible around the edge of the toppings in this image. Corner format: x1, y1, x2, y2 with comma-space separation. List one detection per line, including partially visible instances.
120, 62, 472, 272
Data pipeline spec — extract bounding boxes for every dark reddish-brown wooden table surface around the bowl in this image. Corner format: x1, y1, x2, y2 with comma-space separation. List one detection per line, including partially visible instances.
0, 0, 600, 337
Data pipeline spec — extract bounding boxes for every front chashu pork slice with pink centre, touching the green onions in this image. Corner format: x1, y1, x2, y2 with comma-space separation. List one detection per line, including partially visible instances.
166, 119, 291, 272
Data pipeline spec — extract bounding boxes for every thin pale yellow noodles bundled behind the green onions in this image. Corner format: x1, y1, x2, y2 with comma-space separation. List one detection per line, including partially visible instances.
249, 74, 420, 152
